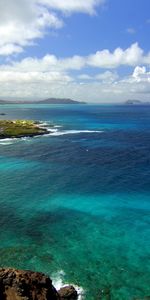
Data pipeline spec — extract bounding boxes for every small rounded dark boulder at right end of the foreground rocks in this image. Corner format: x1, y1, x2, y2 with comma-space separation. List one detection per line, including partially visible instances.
58, 285, 78, 300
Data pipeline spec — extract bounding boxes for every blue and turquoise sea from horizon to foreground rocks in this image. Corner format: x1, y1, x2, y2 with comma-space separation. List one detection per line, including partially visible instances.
0, 105, 150, 300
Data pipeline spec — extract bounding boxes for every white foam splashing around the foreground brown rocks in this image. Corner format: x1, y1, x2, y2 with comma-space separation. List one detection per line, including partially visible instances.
51, 270, 85, 300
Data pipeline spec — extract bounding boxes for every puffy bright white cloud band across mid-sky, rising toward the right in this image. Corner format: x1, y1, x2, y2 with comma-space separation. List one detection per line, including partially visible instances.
0, 43, 150, 71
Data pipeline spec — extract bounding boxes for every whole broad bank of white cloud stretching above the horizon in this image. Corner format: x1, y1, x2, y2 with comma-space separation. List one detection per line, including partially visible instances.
0, 44, 150, 102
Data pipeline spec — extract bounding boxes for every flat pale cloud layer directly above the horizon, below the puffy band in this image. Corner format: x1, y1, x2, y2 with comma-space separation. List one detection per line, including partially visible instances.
0, 73, 150, 103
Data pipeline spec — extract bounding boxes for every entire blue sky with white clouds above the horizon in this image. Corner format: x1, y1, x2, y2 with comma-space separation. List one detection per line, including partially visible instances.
0, 0, 150, 103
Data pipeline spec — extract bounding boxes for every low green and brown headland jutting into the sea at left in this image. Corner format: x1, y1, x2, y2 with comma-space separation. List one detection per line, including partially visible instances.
0, 120, 49, 139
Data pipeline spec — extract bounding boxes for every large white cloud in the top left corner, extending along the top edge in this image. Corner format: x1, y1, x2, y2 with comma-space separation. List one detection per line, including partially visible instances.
0, 0, 104, 56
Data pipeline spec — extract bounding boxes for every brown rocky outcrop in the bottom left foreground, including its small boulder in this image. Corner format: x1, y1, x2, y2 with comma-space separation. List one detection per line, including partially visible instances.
0, 268, 77, 300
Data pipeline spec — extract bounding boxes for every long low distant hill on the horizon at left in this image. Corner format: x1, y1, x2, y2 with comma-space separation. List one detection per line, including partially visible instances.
0, 98, 86, 104
